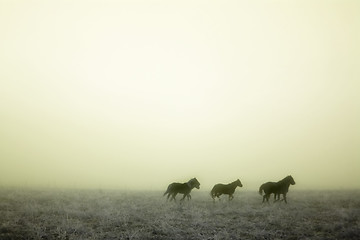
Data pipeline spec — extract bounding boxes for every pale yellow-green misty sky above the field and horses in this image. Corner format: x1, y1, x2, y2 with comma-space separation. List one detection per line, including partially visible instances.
0, 0, 360, 190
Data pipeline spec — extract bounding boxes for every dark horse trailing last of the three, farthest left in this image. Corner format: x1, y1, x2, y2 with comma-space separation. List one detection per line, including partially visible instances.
164, 178, 200, 201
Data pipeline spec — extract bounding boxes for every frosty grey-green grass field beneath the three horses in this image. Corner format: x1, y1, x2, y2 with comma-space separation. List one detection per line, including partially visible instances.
0, 189, 360, 240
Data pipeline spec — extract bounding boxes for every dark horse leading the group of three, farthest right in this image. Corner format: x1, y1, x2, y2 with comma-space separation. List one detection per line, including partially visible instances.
259, 175, 295, 203
